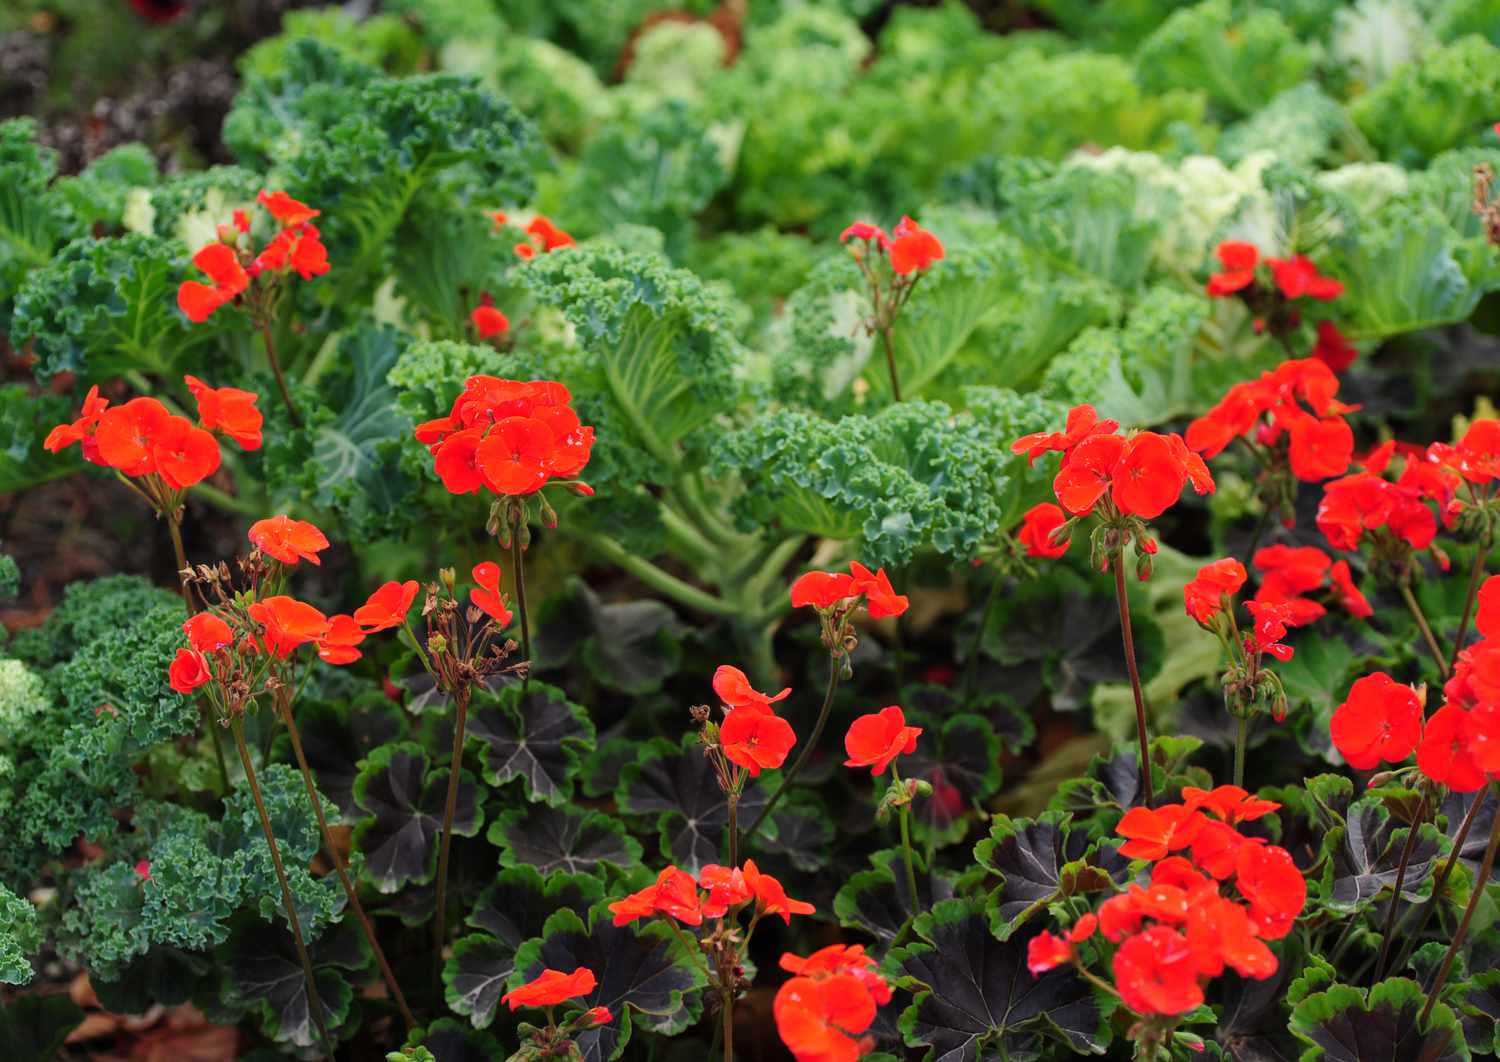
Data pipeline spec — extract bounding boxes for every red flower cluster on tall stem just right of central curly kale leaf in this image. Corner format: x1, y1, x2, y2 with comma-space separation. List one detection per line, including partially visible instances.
1011, 405, 1214, 521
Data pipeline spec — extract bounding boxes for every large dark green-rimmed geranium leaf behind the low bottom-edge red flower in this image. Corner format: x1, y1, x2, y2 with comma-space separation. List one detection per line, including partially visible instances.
512, 905, 707, 1062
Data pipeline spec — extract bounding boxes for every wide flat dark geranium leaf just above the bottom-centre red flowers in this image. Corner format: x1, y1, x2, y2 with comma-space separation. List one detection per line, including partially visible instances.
486, 806, 641, 876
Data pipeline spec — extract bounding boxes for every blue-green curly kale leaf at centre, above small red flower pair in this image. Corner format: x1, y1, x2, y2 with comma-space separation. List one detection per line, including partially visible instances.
714, 402, 1010, 564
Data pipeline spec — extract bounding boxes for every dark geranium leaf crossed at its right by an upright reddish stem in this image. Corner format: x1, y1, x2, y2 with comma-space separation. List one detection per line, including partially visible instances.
354, 741, 485, 893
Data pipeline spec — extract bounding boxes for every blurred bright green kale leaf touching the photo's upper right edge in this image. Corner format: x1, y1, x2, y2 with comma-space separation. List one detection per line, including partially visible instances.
1350, 35, 1500, 167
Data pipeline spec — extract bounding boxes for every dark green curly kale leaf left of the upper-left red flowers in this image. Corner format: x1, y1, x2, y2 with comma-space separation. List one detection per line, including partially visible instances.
12, 233, 226, 381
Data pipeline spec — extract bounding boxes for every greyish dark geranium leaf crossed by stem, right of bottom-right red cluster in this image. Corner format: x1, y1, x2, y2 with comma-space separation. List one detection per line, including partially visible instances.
1320, 797, 1440, 911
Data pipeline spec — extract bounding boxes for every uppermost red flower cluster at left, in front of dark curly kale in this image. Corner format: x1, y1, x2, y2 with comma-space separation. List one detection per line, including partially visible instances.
177, 191, 329, 324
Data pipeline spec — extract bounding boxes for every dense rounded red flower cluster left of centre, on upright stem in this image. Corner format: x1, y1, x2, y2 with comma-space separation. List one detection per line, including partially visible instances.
417, 377, 594, 495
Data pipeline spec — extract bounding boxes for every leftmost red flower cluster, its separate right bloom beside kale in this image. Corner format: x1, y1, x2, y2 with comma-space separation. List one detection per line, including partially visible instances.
42, 377, 263, 495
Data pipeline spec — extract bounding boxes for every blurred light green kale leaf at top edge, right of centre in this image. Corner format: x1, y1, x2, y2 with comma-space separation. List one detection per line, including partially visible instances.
1136, 0, 1317, 114
